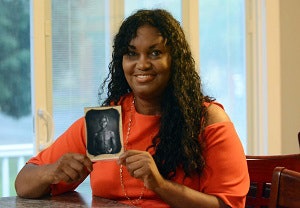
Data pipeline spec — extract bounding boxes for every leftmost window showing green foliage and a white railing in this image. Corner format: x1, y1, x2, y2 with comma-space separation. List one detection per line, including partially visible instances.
0, 0, 33, 197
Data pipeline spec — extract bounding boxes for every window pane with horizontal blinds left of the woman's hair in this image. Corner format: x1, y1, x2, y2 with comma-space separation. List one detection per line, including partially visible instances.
50, 0, 110, 138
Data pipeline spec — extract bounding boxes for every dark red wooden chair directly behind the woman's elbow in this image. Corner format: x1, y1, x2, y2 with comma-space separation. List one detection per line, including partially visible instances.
246, 154, 300, 208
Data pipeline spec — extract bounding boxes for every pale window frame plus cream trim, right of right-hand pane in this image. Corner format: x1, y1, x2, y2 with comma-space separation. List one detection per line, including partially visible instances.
246, 0, 281, 155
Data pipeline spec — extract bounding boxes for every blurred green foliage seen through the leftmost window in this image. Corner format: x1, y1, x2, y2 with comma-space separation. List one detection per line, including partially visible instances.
0, 0, 31, 118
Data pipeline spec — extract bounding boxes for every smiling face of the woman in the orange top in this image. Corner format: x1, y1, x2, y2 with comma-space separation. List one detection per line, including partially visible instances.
122, 25, 171, 99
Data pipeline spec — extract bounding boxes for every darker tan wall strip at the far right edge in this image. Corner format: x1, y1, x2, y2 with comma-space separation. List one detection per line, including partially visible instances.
279, 0, 300, 153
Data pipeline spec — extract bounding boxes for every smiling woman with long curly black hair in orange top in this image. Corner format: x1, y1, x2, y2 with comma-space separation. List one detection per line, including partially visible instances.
16, 10, 249, 208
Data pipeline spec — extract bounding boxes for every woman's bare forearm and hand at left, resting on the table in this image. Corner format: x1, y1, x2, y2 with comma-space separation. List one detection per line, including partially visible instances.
15, 153, 93, 198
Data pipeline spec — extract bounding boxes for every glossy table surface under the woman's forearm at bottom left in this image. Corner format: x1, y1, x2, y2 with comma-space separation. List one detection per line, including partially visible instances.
0, 191, 133, 208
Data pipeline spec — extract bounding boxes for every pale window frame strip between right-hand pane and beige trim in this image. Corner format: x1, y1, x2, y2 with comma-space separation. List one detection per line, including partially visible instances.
246, 0, 268, 155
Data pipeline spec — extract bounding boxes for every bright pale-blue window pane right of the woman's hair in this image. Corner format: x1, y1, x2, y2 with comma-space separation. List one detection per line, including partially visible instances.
199, 0, 247, 151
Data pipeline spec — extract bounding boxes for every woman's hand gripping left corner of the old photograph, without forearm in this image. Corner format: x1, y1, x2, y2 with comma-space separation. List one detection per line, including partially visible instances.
45, 153, 93, 184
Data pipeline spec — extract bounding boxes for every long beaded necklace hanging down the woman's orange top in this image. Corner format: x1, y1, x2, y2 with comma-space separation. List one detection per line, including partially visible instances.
120, 98, 145, 206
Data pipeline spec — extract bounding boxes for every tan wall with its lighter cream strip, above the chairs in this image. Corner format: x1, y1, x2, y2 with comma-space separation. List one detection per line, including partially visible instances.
266, 0, 300, 154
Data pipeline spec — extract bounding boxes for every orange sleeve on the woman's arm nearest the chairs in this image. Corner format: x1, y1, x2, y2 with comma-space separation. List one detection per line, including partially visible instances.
200, 122, 250, 208
